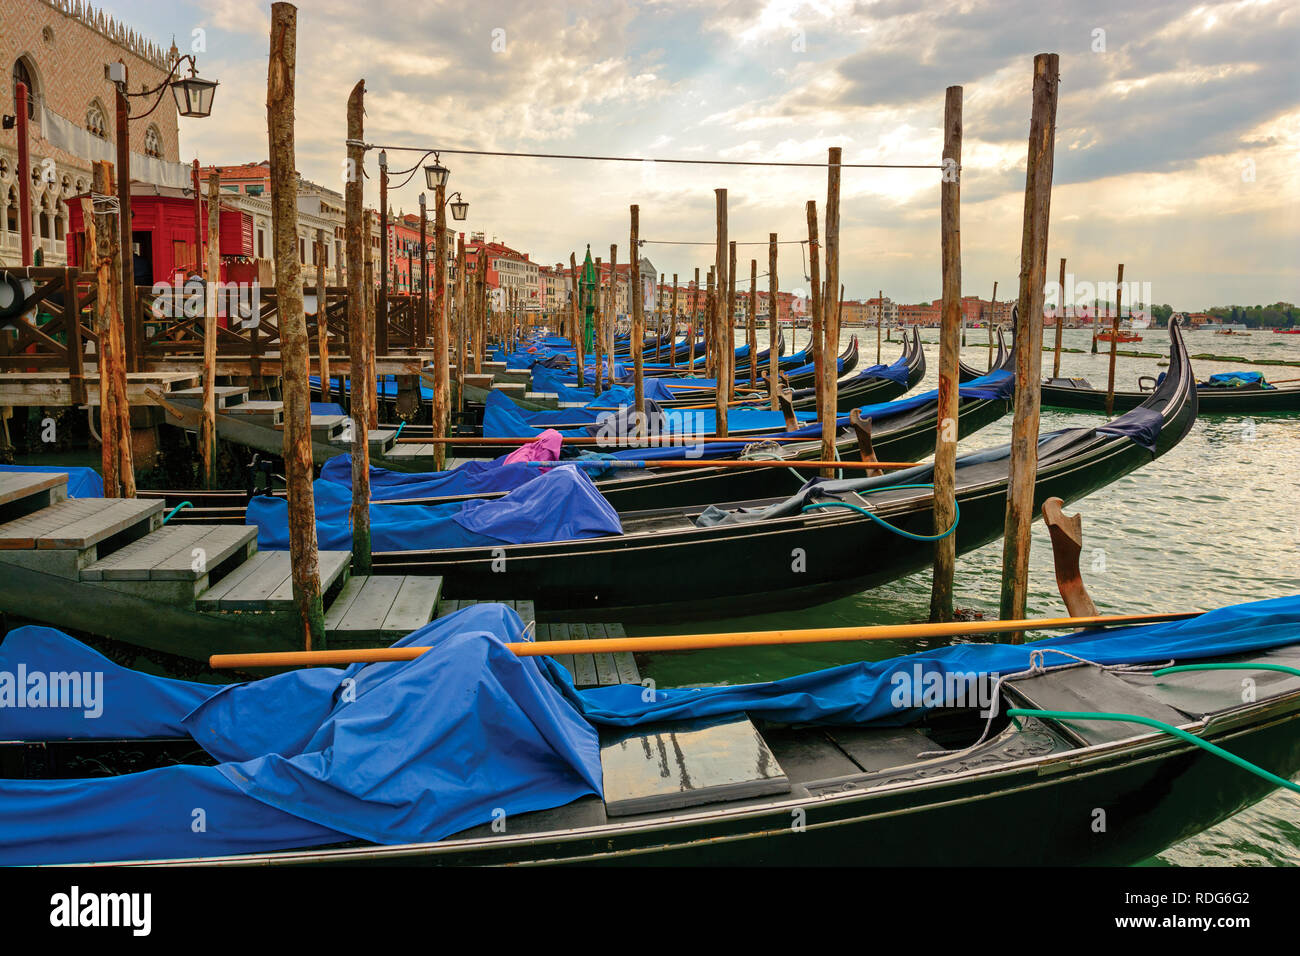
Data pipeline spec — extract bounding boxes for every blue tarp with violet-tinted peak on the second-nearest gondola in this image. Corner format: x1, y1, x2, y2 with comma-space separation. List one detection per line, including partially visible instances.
246, 464, 623, 551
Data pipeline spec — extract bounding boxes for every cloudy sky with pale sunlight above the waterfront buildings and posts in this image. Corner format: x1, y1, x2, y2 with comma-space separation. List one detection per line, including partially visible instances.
108, 0, 1300, 310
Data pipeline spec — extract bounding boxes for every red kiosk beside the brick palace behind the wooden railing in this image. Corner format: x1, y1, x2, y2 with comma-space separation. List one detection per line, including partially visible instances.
68, 183, 256, 286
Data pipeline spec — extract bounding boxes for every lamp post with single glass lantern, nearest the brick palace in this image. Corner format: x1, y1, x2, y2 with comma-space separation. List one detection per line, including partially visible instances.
107, 53, 217, 371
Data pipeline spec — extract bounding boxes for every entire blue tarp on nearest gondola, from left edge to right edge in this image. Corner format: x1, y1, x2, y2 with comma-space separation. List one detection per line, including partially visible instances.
0, 596, 1300, 864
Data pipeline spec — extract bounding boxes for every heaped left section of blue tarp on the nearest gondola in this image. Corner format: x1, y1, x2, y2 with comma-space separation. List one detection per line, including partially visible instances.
0, 605, 601, 865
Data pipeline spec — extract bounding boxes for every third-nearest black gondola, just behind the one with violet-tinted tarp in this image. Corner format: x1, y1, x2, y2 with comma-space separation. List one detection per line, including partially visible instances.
139, 364, 1010, 524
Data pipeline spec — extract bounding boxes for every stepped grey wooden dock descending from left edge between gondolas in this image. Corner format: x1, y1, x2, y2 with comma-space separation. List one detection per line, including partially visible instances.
0, 472, 641, 687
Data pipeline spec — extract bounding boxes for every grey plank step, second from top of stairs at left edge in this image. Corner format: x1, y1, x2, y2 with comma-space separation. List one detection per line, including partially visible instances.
0, 498, 163, 551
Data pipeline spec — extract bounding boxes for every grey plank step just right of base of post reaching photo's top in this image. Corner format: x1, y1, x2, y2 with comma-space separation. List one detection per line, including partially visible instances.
325, 575, 442, 648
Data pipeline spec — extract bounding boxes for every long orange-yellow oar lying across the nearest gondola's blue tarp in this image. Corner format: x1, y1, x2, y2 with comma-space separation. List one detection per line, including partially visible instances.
208, 611, 1203, 669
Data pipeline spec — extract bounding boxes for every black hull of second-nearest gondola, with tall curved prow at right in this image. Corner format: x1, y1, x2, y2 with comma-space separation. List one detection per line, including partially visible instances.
348, 324, 1196, 622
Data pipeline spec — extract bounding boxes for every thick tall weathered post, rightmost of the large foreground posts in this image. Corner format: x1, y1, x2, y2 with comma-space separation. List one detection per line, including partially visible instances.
1001, 53, 1060, 634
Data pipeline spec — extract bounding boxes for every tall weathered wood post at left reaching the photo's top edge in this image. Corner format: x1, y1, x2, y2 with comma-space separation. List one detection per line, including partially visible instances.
267, 3, 325, 650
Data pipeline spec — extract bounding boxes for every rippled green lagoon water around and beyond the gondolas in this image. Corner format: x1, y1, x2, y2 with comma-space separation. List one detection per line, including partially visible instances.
632, 323, 1300, 866
